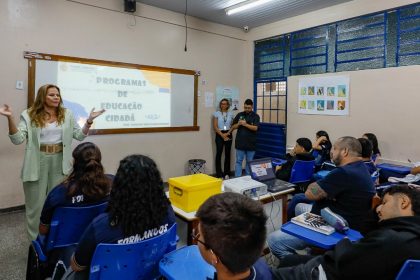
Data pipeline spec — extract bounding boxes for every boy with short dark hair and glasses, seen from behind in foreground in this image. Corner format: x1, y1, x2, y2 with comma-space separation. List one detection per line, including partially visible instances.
193, 192, 272, 280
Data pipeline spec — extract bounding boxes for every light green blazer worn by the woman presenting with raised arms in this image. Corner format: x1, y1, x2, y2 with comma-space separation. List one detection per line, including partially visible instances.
9, 109, 87, 182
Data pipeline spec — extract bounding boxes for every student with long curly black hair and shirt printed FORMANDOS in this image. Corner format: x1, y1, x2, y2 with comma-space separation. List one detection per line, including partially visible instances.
63, 155, 175, 279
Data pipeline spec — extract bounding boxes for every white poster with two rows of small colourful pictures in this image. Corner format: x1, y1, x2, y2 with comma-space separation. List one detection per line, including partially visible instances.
298, 76, 350, 116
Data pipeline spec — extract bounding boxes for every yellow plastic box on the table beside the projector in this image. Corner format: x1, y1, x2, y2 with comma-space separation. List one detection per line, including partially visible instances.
168, 174, 222, 212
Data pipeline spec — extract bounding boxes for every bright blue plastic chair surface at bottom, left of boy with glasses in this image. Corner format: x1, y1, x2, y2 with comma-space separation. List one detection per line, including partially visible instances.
159, 245, 216, 280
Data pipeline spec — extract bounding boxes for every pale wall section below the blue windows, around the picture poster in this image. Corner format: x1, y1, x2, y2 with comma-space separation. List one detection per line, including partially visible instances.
287, 65, 420, 164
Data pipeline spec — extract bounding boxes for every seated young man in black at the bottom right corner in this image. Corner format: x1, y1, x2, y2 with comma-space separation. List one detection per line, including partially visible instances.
273, 185, 420, 280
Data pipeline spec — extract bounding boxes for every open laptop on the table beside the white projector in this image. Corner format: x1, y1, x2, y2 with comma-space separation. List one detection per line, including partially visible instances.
248, 158, 295, 192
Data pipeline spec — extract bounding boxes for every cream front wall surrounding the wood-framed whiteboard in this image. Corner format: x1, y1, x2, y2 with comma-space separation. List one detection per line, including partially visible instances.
0, 0, 252, 209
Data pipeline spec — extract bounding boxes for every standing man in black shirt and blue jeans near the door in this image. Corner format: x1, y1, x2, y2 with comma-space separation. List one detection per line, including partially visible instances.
229, 99, 260, 177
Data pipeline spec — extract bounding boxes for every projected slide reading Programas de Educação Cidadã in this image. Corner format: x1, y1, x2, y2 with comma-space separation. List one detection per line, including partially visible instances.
56, 61, 172, 129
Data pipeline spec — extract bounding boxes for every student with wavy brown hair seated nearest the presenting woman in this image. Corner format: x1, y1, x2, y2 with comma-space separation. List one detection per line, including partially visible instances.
39, 142, 113, 235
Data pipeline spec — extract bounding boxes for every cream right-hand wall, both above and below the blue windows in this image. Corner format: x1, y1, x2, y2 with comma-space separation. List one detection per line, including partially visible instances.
248, 0, 420, 164
